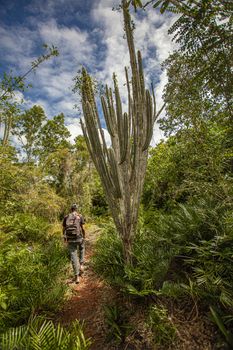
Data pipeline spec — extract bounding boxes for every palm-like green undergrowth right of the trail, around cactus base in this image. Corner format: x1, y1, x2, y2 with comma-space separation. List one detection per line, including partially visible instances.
93, 199, 233, 343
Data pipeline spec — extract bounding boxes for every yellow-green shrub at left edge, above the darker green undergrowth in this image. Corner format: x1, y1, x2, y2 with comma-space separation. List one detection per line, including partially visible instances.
0, 158, 64, 222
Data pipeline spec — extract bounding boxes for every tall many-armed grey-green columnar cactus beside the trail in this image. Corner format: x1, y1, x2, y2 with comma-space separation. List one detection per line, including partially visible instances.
81, 0, 162, 263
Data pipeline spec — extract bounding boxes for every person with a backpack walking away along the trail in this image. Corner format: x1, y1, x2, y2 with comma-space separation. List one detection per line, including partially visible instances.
62, 204, 85, 283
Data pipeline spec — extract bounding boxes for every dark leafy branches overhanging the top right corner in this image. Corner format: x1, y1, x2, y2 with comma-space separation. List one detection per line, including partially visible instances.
131, 0, 233, 121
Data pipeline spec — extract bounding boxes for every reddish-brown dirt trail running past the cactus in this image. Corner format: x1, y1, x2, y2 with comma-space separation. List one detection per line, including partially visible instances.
58, 227, 112, 350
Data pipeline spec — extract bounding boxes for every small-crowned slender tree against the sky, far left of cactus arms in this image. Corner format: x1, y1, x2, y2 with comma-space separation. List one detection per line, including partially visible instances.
12, 106, 46, 163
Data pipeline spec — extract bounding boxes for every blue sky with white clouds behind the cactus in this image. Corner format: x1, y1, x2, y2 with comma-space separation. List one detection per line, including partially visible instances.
0, 0, 174, 142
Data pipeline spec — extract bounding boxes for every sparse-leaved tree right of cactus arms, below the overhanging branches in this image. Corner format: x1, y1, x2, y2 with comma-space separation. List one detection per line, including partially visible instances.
159, 52, 224, 138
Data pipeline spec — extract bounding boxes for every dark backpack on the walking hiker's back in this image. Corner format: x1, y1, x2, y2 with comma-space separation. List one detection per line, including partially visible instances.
65, 213, 83, 241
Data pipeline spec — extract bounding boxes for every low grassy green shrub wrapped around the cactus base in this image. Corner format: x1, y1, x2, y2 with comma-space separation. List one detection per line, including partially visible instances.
93, 221, 176, 296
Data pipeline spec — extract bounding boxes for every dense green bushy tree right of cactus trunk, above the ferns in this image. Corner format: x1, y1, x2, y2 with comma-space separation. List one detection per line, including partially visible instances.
142, 122, 232, 212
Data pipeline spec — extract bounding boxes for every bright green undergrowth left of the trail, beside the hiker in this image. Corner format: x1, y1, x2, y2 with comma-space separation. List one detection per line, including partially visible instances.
0, 214, 67, 331
